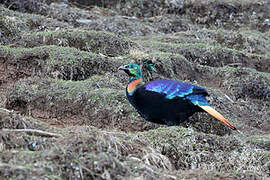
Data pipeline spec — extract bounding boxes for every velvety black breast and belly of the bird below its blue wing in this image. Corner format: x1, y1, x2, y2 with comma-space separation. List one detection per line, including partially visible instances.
127, 87, 203, 126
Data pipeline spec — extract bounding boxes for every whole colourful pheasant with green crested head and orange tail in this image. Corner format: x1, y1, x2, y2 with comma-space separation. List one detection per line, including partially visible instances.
119, 61, 236, 130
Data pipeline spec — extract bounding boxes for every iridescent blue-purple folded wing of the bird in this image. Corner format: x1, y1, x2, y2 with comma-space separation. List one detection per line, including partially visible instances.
144, 80, 209, 106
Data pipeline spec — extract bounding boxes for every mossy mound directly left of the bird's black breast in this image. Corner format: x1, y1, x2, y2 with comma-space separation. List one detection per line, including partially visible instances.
7, 78, 127, 124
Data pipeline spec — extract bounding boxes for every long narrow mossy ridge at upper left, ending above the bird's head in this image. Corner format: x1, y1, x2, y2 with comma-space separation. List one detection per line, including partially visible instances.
21, 29, 136, 56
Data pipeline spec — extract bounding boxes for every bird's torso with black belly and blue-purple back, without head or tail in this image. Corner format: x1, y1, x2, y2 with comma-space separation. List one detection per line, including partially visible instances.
127, 80, 207, 125
